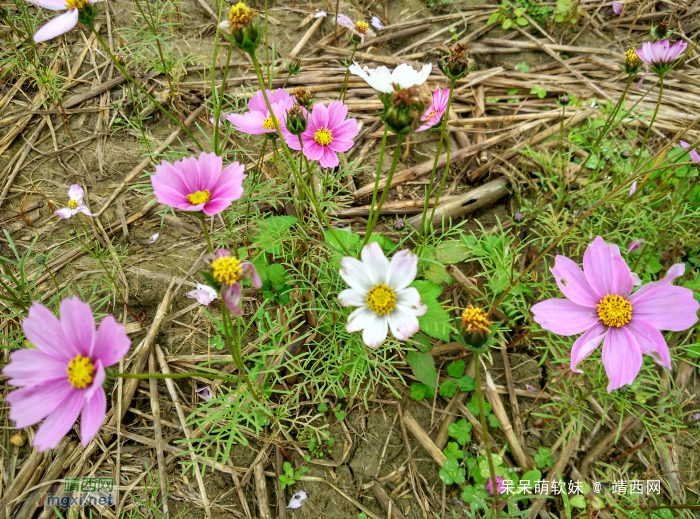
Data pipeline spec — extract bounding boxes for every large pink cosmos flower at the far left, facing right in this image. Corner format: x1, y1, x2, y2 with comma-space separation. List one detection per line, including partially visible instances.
2, 297, 131, 451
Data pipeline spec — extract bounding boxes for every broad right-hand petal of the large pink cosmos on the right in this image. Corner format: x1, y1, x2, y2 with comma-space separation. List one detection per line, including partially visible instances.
628, 282, 700, 332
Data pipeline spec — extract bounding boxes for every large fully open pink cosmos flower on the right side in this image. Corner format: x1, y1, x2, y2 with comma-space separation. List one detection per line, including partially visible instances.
532, 236, 700, 392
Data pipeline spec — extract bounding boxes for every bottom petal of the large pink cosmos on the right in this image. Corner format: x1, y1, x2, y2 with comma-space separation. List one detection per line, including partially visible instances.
603, 326, 642, 393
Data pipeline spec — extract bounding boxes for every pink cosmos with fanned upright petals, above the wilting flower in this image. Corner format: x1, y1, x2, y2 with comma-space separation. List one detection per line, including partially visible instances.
151, 152, 247, 216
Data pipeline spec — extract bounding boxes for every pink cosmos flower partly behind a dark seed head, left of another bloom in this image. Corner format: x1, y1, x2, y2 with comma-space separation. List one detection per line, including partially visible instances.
224, 88, 294, 135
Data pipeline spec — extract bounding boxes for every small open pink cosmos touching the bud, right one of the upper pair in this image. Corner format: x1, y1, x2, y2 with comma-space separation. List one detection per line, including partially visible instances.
283, 101, 360, 168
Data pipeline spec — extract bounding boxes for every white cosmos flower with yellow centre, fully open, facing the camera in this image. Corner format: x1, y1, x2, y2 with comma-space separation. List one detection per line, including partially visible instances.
338, 242, 428, 348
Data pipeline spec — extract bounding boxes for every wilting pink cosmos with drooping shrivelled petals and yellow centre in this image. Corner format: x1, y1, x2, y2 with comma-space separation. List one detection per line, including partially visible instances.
205, 249, 262, 316
